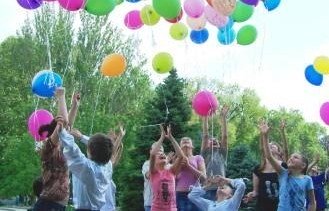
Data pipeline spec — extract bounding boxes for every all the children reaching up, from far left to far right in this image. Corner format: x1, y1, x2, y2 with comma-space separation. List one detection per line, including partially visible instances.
34, 87, 327, 211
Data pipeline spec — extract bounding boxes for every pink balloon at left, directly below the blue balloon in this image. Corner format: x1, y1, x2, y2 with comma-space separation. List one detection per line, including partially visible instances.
27, 109, 54, 141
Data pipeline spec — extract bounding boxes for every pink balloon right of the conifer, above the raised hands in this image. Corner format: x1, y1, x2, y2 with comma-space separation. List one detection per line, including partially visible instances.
192, 90, 218, 116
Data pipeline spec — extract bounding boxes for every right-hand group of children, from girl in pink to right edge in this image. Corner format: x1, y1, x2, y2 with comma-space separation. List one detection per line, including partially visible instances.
142, 111, 329, 211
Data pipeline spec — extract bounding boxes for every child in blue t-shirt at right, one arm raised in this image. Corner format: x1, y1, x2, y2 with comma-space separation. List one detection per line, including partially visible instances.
260, 122, 316, 211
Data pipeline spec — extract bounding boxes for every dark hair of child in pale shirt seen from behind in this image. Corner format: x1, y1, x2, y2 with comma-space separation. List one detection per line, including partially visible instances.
88, 133, 113, 164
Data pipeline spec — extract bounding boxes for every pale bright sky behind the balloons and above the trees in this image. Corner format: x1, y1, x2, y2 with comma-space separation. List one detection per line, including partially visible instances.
0, 0, 329, 126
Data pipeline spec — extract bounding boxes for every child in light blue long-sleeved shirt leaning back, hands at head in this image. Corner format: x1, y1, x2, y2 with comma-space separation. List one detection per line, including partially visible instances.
188, 176, 246, 211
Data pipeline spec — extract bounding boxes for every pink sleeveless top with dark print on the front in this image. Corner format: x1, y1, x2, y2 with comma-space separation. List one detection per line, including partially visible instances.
150, 169, 177, 211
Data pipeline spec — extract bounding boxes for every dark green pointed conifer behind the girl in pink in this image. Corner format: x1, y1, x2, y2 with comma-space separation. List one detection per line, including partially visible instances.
121, 70, 191, 211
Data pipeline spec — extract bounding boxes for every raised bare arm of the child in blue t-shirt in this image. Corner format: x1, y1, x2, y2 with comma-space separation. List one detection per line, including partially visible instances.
259, 121, 281, 173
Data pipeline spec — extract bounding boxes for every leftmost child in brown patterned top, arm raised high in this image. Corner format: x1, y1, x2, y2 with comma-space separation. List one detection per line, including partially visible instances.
34, 87, 69, 211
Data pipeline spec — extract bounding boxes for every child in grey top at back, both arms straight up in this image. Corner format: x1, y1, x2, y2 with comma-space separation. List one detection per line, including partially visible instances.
201, 106, 229, 200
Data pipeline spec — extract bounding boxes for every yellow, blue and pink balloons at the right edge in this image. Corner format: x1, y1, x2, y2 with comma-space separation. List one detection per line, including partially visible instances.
305, 56, 329, 125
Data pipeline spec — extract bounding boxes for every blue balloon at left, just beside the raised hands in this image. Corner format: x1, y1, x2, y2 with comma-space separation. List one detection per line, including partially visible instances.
32, 70, 63, 98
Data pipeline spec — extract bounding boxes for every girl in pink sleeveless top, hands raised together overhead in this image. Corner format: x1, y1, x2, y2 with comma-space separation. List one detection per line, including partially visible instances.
150, 125, 183, 211
